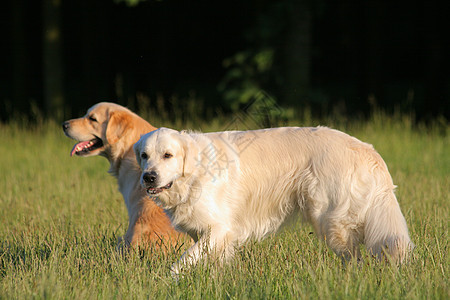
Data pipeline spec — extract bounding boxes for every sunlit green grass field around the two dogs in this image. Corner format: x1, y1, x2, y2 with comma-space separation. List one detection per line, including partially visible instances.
0, 113, 450, 299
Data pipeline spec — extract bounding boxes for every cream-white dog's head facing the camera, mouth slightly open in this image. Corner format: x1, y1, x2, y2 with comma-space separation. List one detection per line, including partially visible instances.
134, 128, 195, 197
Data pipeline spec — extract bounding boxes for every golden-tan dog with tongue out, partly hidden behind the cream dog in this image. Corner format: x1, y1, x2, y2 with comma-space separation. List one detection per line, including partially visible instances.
63, 102, 182, 250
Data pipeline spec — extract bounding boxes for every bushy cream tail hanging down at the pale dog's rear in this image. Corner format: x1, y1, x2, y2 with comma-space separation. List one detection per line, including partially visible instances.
364, 191, 414, 263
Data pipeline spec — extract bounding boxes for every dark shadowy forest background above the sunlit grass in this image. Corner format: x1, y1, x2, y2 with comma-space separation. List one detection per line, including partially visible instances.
0, 0, 450, 121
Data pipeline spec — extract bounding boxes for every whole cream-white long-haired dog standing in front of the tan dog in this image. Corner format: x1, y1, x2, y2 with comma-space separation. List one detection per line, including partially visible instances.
134, 127, 412, 275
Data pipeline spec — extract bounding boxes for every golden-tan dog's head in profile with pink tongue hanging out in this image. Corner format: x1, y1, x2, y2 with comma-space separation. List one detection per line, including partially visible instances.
62, 102, 155, 158
